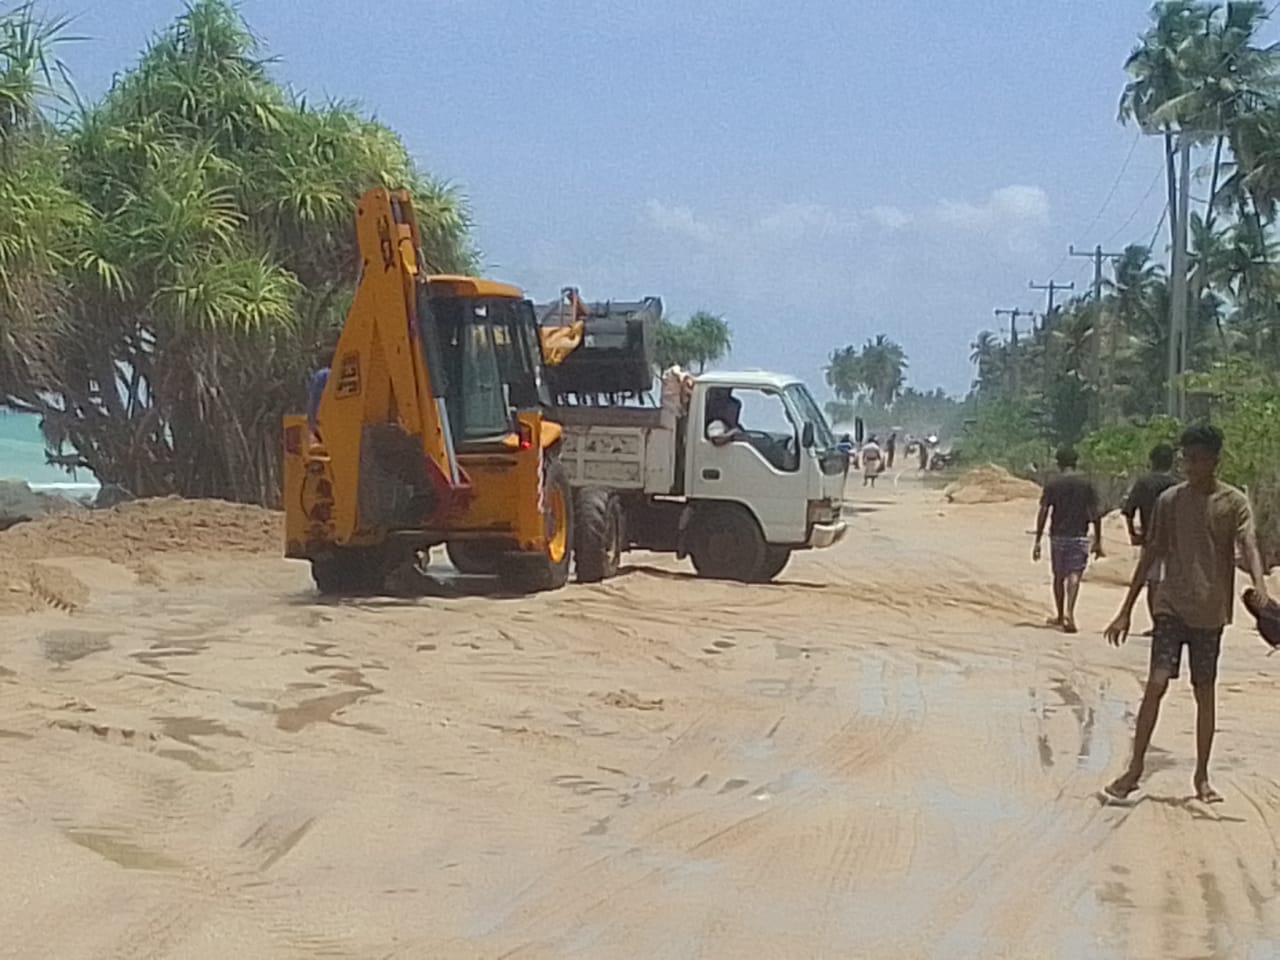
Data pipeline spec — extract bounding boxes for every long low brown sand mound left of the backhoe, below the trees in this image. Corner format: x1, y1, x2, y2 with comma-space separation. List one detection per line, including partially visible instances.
0, 497, 284, 563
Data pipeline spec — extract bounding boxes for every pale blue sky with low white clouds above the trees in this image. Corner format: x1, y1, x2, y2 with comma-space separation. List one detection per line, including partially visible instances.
57, 0, 1218, 399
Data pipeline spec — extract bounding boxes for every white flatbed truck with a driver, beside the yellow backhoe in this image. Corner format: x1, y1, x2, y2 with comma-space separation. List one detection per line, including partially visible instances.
548, 371, 849, 581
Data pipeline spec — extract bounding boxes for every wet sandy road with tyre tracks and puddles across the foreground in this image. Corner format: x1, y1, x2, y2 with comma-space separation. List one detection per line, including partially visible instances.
0, 483, 1280, 960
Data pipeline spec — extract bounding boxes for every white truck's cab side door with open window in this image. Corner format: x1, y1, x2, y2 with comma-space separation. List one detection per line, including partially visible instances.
685, 385, 808, 543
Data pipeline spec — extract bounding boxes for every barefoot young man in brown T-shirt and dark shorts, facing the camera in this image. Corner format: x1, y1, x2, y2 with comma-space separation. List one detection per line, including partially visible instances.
1103, 425, 1267, 804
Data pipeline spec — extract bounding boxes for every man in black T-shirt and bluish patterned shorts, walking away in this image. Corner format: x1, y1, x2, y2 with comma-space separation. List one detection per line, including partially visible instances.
1032, 447, 1102, 634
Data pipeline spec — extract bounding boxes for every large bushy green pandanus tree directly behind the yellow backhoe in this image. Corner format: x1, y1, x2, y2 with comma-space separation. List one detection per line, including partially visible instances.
21, 0, 475, 503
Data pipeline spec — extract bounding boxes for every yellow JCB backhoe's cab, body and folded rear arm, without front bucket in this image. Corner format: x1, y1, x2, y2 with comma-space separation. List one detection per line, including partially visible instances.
283, 189, 581, 594
